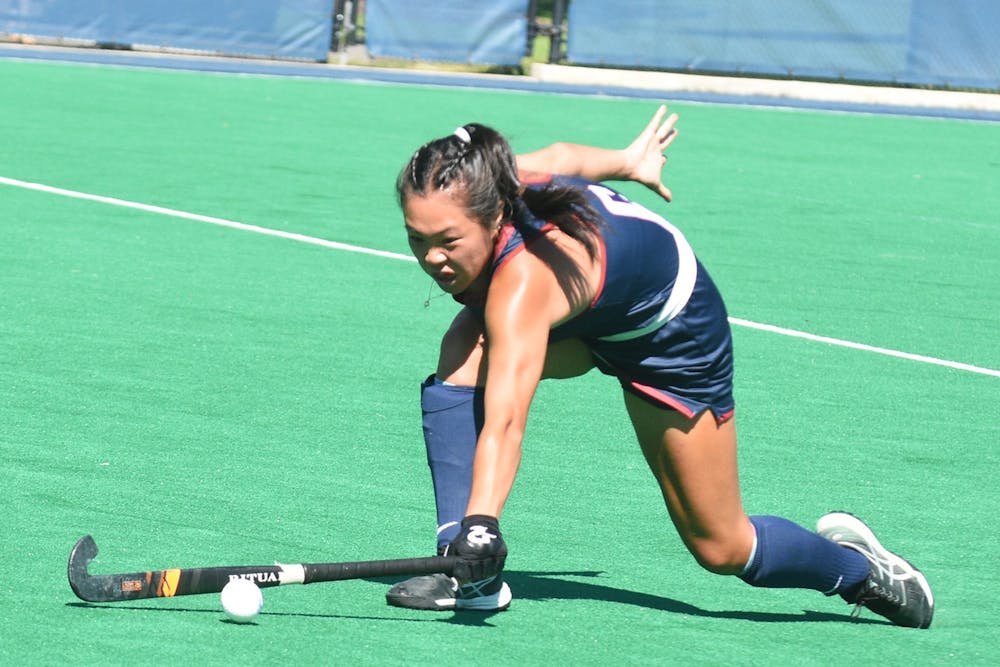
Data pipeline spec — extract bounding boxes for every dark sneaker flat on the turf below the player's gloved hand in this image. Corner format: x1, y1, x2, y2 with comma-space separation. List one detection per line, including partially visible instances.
385, 574, 513, 611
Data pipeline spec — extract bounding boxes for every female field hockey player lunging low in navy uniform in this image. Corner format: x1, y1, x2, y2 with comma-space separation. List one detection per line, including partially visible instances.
387, 107, 934, 628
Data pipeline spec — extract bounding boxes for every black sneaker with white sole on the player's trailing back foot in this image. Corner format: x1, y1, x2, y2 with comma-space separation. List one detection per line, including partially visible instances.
816, 512, 934, 628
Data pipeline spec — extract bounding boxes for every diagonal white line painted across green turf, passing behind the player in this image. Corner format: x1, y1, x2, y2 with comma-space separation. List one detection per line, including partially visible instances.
0, 176, 1000, 377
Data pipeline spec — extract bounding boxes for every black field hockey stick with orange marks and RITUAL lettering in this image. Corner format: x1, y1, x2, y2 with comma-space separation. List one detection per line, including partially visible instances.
68, 535, 455, 602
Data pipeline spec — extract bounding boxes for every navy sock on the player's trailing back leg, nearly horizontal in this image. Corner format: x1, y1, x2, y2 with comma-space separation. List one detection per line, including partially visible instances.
739, 516, 868, 595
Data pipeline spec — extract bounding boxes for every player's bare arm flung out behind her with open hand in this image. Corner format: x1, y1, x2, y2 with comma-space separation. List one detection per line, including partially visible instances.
517, 105, 677, 202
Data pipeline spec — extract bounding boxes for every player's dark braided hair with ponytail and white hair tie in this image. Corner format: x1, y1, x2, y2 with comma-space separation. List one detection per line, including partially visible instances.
396, 123, 602, 258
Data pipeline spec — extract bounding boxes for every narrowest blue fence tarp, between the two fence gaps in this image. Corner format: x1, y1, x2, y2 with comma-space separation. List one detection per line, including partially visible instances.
365, 0, 528, 65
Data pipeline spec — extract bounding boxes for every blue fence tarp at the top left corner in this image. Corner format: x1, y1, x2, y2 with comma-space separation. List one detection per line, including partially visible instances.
0, 0, 333, 61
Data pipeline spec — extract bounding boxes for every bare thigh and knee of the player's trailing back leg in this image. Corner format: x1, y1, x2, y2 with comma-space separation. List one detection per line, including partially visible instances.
625, 392, 754, 574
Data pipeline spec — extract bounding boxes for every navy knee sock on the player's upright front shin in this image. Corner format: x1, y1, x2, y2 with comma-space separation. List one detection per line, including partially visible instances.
420, 375, 483, 551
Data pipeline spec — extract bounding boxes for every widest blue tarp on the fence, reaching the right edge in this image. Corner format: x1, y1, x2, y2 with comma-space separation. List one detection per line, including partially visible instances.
567, 0, 1000, 89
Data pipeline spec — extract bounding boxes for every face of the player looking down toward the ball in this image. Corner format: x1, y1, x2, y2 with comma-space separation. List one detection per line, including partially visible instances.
403, 190, 499, 294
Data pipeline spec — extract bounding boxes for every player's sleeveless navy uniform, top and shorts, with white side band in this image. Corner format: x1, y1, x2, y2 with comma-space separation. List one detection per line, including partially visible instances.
460, 177, 734, 420
